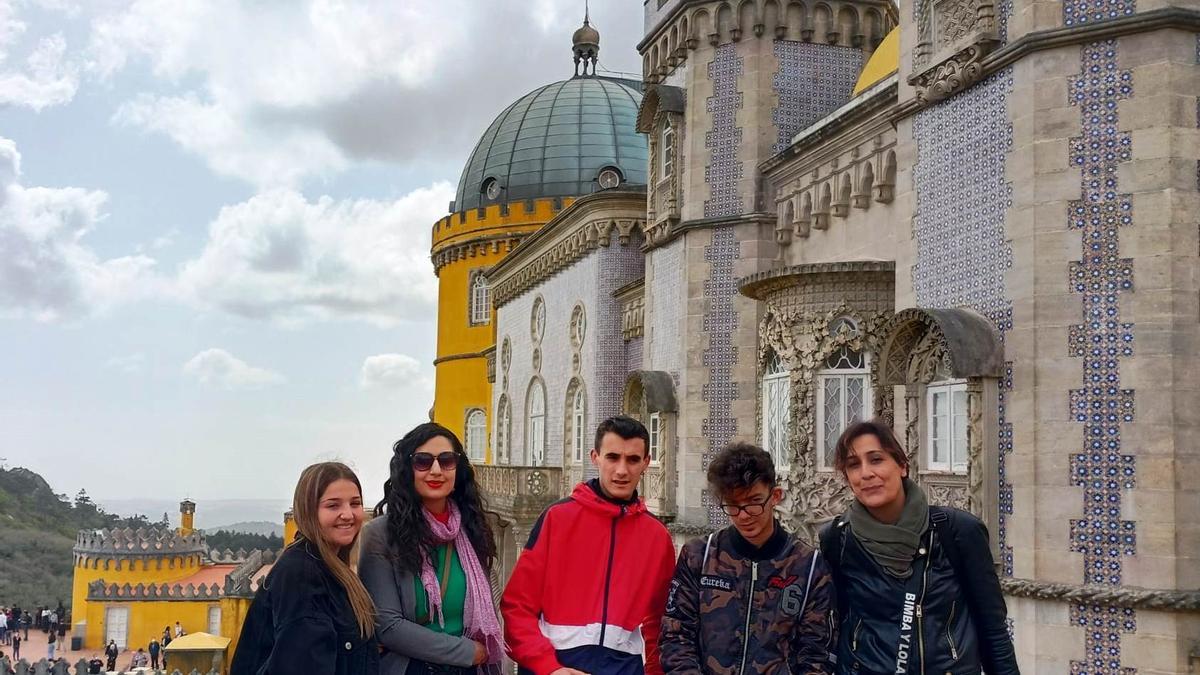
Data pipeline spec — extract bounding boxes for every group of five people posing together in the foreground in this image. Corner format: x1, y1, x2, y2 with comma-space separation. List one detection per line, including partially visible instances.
232, 417, 1019, 675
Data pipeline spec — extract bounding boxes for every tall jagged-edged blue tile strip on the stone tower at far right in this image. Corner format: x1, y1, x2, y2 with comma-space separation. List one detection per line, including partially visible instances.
1063, 38, 1138, 674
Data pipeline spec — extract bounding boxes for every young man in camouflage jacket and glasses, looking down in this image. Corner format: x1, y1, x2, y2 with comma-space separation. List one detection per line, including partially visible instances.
659, 443, 838, 675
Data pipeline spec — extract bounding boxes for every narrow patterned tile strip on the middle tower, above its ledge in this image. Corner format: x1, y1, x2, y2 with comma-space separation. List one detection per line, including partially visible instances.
704, 43, 744, 217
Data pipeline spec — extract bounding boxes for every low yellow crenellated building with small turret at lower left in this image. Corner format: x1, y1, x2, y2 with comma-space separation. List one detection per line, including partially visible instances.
71, 501, 275, 655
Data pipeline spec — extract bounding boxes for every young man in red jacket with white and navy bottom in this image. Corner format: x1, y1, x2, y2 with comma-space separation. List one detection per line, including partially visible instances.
500, 417, 674, 675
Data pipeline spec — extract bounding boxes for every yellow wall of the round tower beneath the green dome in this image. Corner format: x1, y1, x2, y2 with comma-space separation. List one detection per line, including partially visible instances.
432, 198, 572, 462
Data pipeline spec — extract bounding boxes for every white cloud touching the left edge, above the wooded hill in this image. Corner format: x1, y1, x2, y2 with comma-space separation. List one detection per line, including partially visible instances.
0, 138, 166, 321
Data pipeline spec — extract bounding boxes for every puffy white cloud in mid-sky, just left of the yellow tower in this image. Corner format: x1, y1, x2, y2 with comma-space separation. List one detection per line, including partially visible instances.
180, 183, 454, 325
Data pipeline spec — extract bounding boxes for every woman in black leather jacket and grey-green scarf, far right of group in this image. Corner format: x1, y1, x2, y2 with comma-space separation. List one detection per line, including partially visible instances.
821, 420, 1020, 675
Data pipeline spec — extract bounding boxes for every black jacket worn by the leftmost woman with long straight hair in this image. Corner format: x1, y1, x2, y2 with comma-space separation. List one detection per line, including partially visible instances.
229, 540, 379, 675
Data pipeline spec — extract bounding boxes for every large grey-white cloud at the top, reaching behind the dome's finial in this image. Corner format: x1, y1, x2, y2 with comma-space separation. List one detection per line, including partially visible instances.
88, 0, 642, 189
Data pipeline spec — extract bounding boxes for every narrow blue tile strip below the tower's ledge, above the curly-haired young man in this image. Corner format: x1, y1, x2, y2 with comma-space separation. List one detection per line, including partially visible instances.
701, 227, 739, 525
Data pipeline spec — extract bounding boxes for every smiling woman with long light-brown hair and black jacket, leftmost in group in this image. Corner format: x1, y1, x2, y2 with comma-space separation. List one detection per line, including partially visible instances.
229, 462, 379, 675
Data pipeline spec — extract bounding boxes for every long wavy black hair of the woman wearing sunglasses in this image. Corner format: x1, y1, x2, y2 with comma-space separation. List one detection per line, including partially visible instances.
374, 422, 496, 574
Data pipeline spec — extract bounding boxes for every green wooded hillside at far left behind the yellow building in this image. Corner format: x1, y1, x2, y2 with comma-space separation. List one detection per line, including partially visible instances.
0, 467, 171, 607
